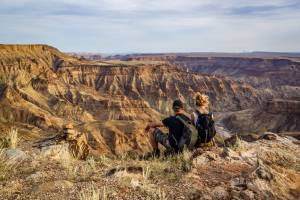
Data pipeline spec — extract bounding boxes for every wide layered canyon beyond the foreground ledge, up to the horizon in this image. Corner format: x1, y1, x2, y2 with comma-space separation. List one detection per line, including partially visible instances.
0, 45, 300, 154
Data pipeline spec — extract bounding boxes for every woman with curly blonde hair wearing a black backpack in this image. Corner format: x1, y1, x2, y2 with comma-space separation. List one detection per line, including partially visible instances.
191, 93, 216, 147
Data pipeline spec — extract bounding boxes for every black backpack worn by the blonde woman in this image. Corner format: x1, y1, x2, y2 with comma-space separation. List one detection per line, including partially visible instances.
195, 110, 216, 144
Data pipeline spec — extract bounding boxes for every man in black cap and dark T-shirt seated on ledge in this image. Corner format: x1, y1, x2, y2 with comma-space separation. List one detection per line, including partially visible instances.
145, 100, 191, 156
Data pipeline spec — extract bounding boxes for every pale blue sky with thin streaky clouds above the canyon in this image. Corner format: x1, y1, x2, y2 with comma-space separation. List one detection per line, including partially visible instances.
0, 0, 300, 53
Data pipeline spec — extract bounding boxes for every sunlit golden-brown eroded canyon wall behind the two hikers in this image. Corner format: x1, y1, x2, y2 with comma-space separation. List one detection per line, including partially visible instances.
0, 45, 263, 154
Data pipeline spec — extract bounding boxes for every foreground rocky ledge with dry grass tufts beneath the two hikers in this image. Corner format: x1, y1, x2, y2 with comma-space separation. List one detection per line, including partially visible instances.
0, 133, 300, 200
